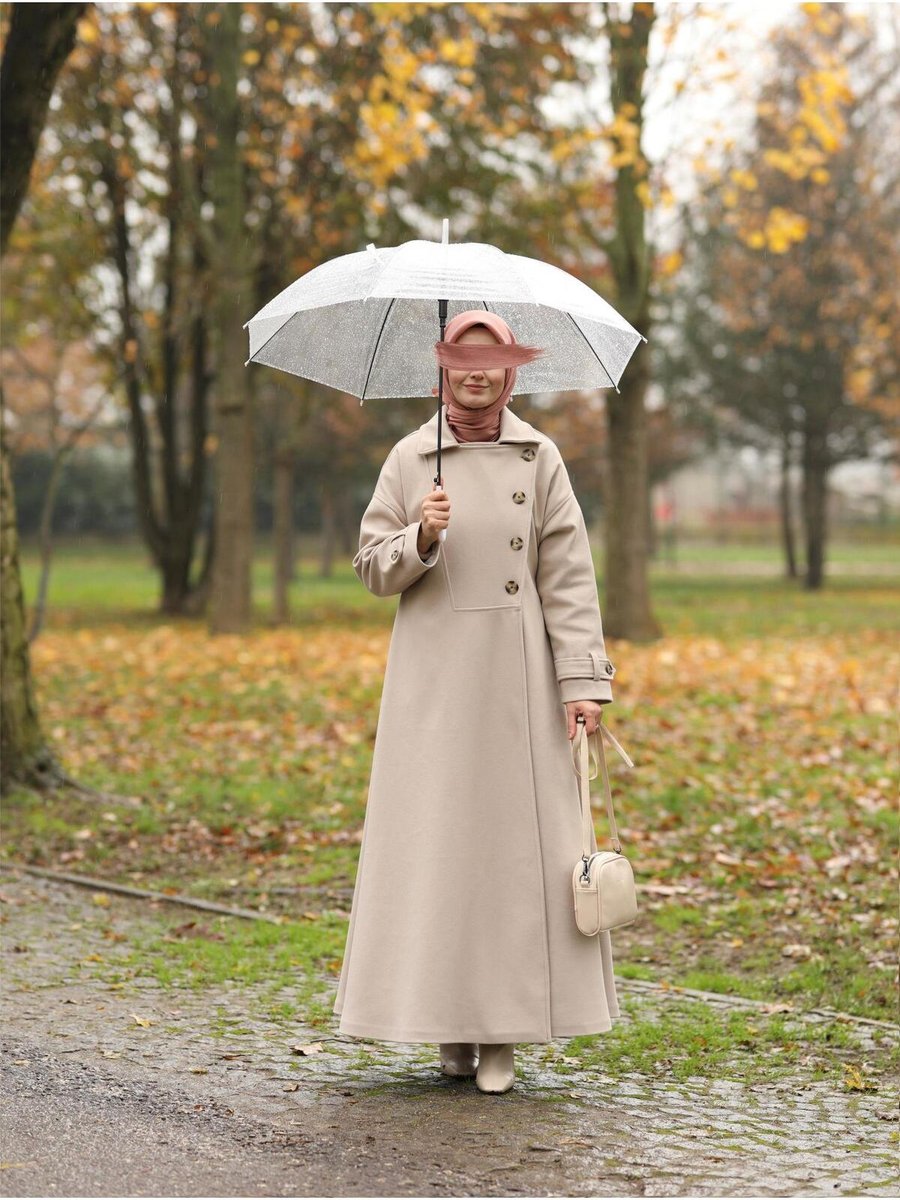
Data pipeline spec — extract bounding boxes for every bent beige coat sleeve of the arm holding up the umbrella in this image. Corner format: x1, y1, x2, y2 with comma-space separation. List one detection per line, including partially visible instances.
353, 446, 442, 596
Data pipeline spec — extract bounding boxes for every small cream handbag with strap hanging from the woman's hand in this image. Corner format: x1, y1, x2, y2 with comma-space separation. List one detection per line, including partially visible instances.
572, 714, 637, 937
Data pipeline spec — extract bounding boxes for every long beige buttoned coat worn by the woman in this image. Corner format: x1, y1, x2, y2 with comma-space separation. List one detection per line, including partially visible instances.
334, 406, 619, 1043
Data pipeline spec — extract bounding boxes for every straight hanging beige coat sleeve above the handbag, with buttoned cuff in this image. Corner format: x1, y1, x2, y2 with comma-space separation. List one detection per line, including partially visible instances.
535, 456, 616, 704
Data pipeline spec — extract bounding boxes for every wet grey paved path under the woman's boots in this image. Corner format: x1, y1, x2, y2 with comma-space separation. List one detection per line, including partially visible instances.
0, 871, 900, 1196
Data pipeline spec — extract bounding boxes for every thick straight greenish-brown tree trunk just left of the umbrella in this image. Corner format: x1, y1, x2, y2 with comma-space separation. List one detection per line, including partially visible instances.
204, 4, 253, 634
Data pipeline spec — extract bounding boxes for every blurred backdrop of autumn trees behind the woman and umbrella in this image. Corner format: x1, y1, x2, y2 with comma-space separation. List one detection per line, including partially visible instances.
0, 4, 900, 792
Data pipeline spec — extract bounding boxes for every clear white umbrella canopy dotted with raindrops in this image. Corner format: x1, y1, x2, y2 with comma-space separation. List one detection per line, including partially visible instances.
244, 230, 647, 402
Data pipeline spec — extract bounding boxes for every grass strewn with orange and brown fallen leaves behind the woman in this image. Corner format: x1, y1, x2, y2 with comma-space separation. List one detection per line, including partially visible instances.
14, 623, 900, 1017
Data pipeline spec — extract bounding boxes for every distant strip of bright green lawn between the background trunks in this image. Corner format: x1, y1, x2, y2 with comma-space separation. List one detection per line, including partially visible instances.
14, 538, 900, 637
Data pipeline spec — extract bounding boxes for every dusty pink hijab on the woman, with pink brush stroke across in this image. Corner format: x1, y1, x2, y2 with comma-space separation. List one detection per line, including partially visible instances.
434, 308, 544, 442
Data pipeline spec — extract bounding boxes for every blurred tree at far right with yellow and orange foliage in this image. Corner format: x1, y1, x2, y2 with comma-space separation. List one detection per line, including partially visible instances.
682, 5, 900, 588
